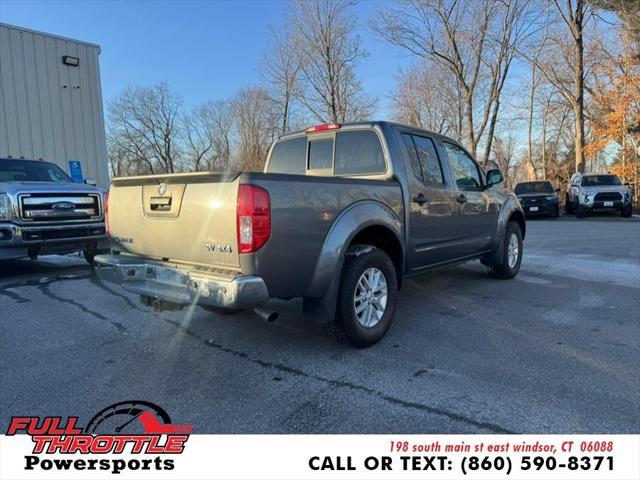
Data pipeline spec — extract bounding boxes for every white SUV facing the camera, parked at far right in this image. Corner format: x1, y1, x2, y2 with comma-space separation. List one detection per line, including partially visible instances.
565, 173, 633, 218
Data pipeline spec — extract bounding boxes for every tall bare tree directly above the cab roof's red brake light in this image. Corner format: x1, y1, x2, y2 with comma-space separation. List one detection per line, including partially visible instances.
289, 0, 374, 122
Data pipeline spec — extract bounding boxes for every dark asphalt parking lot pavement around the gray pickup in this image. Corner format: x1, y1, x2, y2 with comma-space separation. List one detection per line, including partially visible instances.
0, 217, 640, 433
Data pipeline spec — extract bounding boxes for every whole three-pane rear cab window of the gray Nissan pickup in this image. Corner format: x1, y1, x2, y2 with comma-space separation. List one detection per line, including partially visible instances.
267, 130, 387, 176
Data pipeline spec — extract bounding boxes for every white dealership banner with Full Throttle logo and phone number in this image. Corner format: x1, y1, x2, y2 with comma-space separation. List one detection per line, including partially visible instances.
0, 434, 640, 480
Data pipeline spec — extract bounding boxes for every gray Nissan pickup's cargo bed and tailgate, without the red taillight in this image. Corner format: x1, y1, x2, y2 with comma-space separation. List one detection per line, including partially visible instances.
109, 172, 403, 298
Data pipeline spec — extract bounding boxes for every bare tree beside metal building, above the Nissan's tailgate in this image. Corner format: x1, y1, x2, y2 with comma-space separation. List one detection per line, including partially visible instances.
108, 84, 181, 174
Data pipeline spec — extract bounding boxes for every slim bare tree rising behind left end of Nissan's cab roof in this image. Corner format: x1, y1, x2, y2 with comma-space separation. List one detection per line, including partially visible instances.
260, 28, 300, 136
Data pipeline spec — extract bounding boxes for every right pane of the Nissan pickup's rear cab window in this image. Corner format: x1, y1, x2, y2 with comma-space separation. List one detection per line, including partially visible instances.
335, 130, 387, 175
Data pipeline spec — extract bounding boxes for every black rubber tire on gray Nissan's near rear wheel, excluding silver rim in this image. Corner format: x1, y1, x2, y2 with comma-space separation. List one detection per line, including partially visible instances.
335, 245, 398, 348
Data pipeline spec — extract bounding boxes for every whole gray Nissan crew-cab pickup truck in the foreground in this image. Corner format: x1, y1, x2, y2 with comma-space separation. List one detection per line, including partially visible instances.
96, 122, 525, 347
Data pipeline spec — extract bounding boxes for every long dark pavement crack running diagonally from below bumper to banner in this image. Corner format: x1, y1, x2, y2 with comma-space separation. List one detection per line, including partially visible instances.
160, 317, 517, 434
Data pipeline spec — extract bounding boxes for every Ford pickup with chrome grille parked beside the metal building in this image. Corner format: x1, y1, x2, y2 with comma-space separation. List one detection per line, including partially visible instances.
0, 158, 109, 263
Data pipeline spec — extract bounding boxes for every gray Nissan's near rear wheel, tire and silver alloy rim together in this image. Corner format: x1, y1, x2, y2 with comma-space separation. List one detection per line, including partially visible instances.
335, 245, 398, 348
